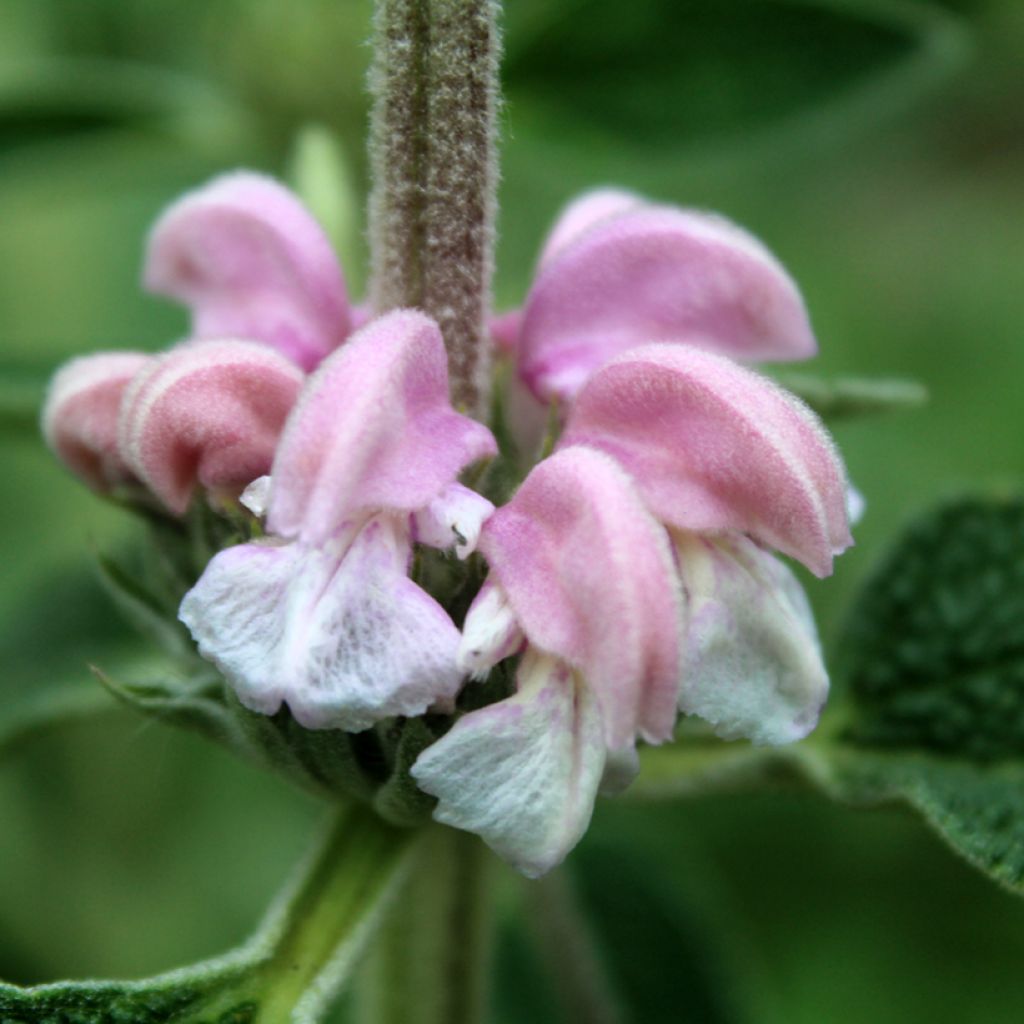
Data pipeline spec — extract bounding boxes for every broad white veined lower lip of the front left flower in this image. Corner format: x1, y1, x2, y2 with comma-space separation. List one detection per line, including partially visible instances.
180, 515, 462, 732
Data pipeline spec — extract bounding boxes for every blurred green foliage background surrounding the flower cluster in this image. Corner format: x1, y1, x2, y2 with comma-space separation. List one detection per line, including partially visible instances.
0, 0, 1024, 1024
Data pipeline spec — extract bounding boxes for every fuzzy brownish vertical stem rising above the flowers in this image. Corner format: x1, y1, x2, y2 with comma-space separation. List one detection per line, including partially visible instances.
370, 0, 500, 415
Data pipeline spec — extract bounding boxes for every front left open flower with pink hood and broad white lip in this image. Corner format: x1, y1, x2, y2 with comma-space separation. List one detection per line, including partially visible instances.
180, 310, 496, 732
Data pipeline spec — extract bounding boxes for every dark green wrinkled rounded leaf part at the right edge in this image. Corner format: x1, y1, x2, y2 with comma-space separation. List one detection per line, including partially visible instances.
844, 499, 1024, 762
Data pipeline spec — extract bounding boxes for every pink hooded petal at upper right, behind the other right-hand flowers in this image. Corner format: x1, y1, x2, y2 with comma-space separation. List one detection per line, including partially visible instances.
518, 206, 816, 401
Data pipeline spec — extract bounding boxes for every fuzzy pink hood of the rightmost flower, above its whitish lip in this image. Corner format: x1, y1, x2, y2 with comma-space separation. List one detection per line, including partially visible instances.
561, 345, 852, 575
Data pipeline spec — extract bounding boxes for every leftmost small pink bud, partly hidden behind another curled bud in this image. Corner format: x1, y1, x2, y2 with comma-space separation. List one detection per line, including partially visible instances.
42, 352, 152, 494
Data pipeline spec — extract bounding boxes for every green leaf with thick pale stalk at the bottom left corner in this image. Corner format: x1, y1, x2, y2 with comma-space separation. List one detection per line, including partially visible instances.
0, 806, 414, 1024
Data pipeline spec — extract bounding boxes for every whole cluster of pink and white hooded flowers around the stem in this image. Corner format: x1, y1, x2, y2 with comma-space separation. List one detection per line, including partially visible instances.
43, 173, 850, 876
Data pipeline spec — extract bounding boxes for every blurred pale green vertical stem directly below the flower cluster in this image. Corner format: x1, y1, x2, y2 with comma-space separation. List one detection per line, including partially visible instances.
358, 826, 493, 1024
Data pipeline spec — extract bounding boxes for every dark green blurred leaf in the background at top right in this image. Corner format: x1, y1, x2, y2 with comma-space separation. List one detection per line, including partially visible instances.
507, 0, 964, 155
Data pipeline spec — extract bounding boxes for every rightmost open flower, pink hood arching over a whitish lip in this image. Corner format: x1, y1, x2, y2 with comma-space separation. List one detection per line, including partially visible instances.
560, 345, 852, 743
